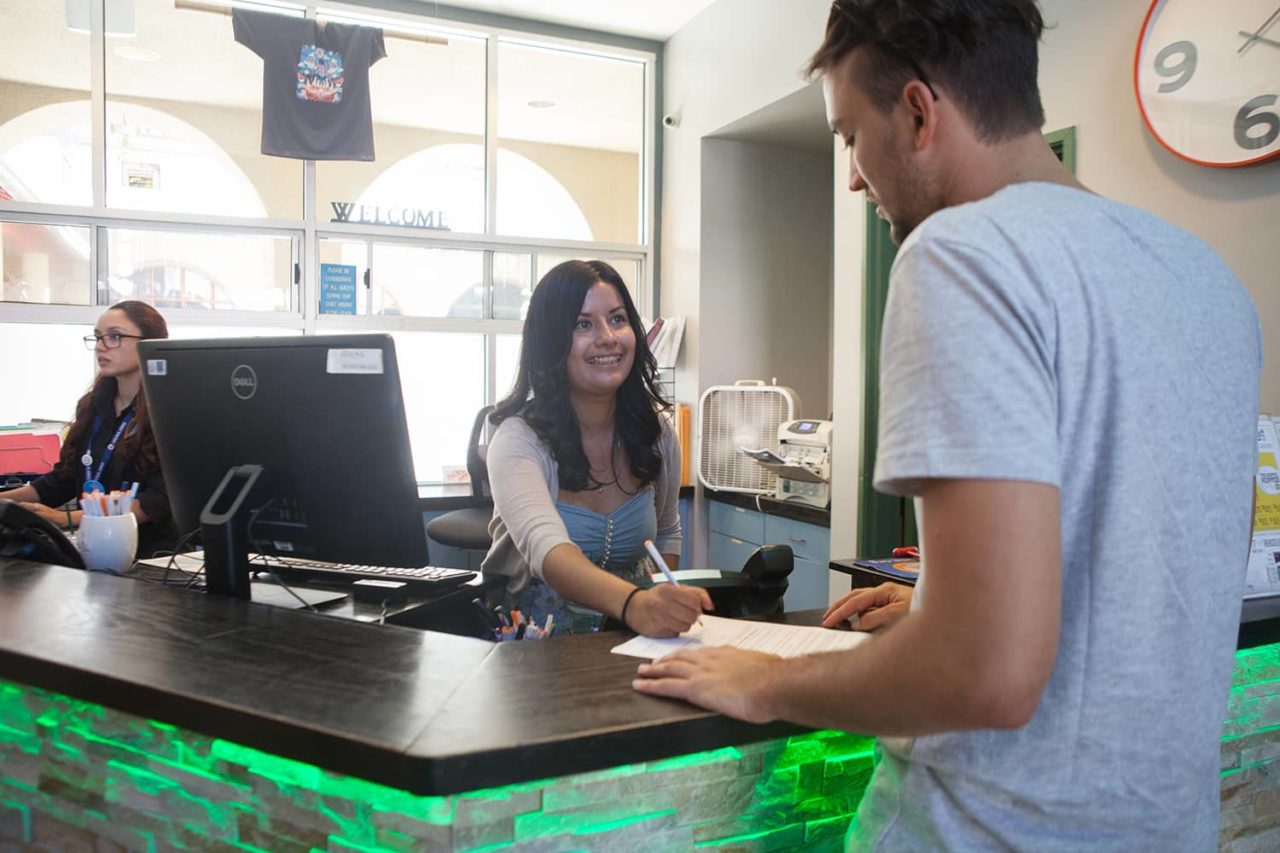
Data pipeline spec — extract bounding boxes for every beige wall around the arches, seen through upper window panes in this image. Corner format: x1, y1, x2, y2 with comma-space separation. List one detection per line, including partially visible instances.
0, 81, 640, 243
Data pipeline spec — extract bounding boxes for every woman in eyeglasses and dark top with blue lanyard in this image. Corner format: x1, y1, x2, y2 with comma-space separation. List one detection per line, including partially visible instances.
0, 300, 177, 557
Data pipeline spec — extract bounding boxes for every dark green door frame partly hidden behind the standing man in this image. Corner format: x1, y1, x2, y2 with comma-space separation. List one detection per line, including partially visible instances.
855, 127, 1075, 557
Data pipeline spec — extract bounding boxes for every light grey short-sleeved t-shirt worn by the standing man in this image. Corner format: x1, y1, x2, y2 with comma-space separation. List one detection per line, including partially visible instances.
849, 183, 1262, 850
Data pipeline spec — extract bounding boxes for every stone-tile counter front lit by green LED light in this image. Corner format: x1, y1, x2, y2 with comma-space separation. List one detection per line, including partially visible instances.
10, 644, 1280, 853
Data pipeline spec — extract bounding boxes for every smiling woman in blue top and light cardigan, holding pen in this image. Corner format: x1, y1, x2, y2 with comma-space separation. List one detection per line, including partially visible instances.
483, 260, 710, 637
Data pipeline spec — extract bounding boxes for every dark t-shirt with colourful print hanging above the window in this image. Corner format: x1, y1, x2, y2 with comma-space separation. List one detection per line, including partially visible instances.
232, 9, 387, 160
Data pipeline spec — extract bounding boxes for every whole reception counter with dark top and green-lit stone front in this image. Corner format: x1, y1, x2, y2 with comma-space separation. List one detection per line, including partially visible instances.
0, 561, 1280, 850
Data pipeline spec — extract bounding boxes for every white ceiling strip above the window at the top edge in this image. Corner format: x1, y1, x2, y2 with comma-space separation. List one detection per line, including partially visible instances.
407, 0, 714, 41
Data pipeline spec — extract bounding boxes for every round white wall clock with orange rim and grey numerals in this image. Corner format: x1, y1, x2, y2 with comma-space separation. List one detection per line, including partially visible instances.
1133, 0, 1280, 167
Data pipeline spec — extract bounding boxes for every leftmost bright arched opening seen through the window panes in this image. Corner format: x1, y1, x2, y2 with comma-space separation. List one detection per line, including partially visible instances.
0, 101, 273, 309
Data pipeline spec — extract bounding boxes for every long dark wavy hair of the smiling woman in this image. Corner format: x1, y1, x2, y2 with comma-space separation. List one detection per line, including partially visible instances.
489, 260, 673, 492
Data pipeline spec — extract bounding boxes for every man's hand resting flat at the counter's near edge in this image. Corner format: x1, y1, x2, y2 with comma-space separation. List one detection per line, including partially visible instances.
631, 646, 782, 722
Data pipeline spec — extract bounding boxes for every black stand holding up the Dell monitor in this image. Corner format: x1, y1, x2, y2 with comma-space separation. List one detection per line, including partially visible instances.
200, 465, 265, 599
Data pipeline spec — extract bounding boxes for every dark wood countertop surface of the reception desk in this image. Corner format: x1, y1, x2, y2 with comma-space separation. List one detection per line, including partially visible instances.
0, 561, 804, 795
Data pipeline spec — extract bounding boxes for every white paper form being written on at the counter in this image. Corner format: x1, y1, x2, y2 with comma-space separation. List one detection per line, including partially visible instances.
611, 613, 869, 658
